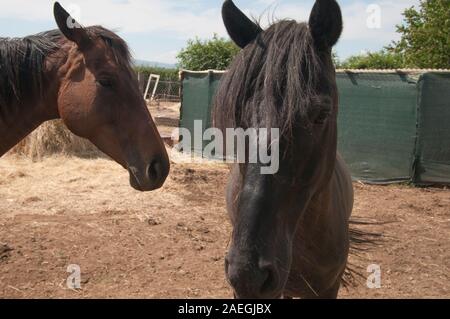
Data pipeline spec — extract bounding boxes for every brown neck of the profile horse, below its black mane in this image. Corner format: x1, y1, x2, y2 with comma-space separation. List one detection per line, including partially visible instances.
0, 101, 54, 157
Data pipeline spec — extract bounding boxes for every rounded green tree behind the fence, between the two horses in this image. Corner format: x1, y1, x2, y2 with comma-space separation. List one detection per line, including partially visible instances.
177, 34, 240, 71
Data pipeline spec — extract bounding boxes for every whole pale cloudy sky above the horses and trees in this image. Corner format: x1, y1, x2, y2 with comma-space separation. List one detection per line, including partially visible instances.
0, 0, 419, 62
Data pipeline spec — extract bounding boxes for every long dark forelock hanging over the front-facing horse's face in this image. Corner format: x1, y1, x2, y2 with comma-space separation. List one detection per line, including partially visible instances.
213, 20, 323, 138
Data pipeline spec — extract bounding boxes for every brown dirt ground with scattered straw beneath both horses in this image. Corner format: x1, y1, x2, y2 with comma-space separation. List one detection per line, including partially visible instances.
0, 156, 450, 298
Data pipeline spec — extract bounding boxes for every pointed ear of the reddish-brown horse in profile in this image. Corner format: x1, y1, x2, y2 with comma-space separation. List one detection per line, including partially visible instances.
53, 2, 90, 48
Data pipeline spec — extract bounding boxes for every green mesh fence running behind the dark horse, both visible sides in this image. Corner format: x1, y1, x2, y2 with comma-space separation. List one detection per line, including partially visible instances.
180, 71, 450, 184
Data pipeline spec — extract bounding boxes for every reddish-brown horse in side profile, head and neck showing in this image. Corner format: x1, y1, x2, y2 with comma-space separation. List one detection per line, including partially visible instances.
0, 3, 170, 191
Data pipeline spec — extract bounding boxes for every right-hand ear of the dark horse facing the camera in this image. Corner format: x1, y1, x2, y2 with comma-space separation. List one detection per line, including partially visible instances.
309, 0, 342, 48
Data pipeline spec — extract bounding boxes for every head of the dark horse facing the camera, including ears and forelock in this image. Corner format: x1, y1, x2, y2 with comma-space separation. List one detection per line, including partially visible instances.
214, 0, 342, 298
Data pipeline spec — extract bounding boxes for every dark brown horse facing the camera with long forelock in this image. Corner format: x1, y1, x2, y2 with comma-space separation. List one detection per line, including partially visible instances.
213, 0, 353, 298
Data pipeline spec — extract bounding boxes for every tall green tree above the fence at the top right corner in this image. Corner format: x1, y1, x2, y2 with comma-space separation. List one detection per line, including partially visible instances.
388, 0, 450, 68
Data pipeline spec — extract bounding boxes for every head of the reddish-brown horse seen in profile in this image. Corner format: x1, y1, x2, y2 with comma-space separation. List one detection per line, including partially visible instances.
48, 3, 170, 191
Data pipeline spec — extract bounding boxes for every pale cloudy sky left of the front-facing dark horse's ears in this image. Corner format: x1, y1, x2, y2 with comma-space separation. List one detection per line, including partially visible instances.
0, 0, 229, 38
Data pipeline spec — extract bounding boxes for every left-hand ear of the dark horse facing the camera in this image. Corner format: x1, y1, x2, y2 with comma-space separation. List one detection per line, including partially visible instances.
222, 0, 262, 48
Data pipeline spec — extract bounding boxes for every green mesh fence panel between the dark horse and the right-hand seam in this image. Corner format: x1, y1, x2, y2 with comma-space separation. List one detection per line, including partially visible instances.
337, 73, 417, 183
